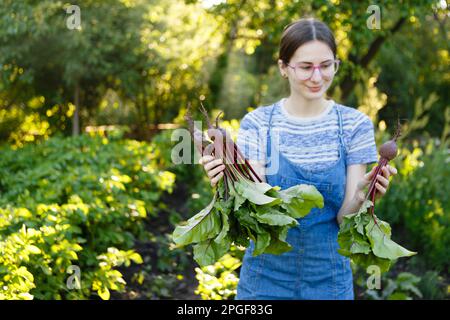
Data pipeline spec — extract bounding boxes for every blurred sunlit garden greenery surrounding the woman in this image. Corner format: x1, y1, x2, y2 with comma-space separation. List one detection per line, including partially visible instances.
0, 0, 450, 299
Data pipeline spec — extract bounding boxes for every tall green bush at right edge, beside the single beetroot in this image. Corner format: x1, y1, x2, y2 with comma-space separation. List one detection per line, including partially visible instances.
379, 141, 450, 272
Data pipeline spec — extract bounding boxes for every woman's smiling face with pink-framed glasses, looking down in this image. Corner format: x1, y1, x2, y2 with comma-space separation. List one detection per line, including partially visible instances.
278, 40, 335, 100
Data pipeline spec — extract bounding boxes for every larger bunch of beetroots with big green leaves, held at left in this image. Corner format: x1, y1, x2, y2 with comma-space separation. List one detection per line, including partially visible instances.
173, 106, 323, 266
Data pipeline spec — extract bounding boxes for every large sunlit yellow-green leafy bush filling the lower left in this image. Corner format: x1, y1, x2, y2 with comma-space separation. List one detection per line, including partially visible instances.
0, 136, 175, 299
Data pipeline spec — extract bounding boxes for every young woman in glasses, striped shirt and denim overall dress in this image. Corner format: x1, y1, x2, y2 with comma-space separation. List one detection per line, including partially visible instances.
200, 19, 396, 299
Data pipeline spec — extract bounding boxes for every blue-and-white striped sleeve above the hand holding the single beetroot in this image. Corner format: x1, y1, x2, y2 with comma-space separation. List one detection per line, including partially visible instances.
347, 114, 378, 165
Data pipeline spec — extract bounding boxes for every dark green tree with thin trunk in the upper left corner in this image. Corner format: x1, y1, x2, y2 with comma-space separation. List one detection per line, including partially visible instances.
0, 0, 148, 135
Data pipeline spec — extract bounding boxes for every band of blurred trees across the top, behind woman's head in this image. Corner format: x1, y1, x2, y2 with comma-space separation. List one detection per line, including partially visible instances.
0, 0, 449, 139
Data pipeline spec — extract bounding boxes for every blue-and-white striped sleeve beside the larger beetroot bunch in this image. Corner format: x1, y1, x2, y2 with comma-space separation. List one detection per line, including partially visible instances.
236, 110, 265, 161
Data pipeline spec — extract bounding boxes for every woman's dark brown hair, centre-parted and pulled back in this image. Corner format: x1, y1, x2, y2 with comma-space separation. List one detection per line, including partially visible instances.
279, 18, 336, 63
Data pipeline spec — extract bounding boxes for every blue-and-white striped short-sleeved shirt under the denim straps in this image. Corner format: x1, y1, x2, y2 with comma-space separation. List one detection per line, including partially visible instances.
237, 98, 378, 169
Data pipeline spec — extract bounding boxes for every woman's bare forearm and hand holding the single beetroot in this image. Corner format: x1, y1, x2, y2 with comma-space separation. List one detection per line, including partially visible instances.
337, 164, 397, 223
